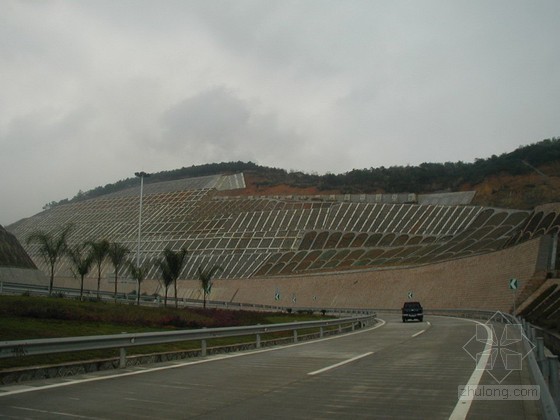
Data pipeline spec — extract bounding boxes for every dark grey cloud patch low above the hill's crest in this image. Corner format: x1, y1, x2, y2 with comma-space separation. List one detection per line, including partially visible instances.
159, 87, 298, 166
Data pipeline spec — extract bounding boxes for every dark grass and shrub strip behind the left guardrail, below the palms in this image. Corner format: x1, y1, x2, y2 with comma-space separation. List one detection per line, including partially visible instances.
0, 296, 328, 370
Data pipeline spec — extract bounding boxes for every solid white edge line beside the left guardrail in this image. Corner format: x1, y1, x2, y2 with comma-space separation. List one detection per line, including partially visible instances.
0, 318, 386, 398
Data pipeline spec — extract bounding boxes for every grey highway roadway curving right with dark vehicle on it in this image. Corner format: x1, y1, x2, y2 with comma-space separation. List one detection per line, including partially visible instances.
0, 314, 539, 419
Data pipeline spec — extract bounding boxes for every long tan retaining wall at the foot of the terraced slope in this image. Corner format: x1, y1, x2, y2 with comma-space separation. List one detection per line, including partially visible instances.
25, 236, 551, 311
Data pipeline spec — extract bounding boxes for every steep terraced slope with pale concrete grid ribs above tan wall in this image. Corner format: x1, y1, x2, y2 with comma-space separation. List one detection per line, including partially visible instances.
9, 174, 530, 279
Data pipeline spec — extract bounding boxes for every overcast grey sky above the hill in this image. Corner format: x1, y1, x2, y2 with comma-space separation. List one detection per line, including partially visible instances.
0, 0, 560, 226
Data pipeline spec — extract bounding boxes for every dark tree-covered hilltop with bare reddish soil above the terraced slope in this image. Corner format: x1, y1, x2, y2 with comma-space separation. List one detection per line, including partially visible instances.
45, 137, 560, 209
